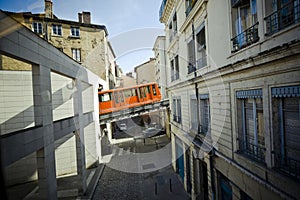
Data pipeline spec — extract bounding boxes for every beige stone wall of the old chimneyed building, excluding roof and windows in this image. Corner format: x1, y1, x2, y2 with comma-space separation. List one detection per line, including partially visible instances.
3, 14, 109, 80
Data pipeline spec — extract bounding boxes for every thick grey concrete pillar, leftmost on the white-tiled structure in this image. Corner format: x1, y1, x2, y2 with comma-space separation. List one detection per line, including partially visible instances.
32, 65, 57, 199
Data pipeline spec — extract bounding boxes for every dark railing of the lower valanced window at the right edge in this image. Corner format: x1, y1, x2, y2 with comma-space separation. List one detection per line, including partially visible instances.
275, 155, 300, 179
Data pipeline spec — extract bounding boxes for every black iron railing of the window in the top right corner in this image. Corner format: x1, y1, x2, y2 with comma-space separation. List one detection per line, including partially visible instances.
265, 0, 300, 36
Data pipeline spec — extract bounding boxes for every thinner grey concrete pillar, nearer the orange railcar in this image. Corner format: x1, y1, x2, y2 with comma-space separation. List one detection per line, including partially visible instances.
73, 80, 87, 195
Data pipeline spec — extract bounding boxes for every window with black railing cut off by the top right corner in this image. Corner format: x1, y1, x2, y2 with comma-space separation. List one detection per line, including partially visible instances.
265, 0, 300, 35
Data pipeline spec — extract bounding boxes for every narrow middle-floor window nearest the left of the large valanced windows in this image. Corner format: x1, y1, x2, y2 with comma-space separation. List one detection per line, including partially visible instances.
199, 94, 210, 134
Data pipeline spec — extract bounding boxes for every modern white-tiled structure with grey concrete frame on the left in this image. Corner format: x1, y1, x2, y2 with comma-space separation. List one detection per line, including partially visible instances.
0, 11, 105, 199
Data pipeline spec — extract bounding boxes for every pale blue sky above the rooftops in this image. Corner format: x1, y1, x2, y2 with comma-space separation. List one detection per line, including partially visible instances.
0, 0, 164, 73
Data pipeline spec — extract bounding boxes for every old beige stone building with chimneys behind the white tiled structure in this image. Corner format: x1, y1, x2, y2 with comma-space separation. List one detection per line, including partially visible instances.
2, 0, 118, 89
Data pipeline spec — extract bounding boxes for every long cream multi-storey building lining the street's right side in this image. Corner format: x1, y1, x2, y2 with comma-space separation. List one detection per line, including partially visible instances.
160, 0, 300, 199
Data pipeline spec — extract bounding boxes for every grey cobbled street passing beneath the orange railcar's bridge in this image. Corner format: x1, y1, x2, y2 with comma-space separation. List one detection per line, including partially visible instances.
93, 136, 189, 200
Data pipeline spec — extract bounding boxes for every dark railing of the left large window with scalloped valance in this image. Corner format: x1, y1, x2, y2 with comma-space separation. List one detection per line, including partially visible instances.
238, 136, 266, 163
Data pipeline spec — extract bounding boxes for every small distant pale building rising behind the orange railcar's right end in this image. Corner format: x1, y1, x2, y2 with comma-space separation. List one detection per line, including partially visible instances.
134, 58, 155, 85
